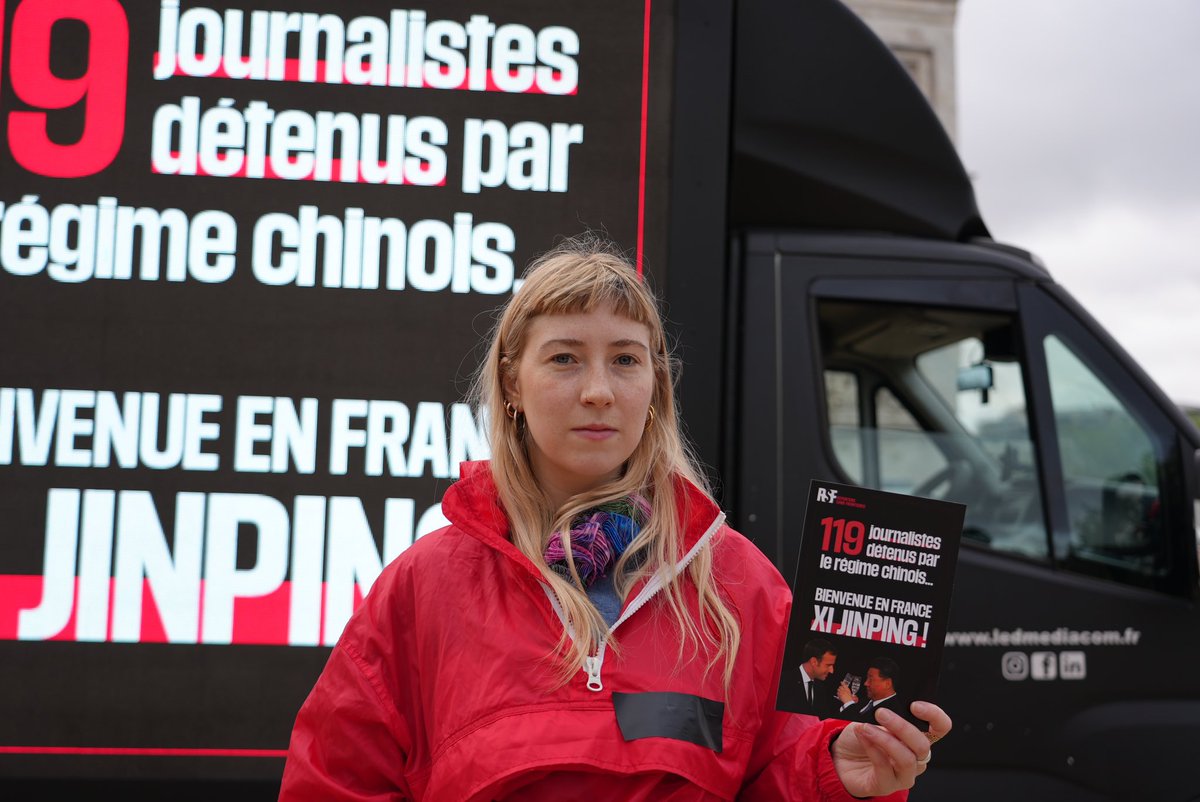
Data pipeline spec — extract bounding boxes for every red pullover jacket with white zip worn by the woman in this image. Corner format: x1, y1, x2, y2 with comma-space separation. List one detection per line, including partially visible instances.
280, 462, 902, 802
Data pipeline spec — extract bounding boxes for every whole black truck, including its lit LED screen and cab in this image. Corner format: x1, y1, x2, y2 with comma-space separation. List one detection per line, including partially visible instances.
0, 0, 1200, 801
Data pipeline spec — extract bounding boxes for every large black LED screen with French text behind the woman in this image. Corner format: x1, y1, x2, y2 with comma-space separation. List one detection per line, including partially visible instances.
0, 0, 668, 778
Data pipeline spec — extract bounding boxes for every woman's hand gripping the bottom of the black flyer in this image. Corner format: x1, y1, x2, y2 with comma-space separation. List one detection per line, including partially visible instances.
833, 702, 952, 796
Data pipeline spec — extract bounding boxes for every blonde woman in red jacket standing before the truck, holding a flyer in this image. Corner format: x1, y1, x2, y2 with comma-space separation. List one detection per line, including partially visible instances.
280, 238, 950, 802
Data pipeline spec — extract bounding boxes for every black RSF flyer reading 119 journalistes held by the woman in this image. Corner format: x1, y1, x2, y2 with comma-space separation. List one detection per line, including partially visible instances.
776, 480, 966, 729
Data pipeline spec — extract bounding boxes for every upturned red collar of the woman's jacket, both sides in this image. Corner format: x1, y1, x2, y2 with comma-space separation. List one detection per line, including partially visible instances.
442, 460, 720, 579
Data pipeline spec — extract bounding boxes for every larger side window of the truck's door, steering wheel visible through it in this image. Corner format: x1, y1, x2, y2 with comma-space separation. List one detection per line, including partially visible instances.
818, 300, 1050, 561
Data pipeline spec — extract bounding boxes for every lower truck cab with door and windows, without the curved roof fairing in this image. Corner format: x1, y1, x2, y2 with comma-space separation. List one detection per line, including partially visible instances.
738, 232, 1200, 800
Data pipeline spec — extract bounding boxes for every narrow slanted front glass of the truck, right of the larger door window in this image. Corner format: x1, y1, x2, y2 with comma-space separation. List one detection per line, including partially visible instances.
1043, 335, 1168, 577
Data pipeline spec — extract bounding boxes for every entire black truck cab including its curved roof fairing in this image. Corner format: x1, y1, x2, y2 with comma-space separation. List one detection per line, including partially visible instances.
666, 1, 1200, 800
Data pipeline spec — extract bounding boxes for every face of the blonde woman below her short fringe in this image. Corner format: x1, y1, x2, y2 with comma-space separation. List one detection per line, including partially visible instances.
504, 307, 654, 508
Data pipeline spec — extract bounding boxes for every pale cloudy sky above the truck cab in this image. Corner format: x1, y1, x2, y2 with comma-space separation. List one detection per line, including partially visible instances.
955, 0, 1200, 407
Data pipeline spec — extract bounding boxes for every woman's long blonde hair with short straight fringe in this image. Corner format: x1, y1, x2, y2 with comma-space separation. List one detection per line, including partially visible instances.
474, 233, 740, 689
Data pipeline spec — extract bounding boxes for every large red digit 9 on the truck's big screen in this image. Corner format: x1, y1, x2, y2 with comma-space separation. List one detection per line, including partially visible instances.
8, 0, 130, 178
